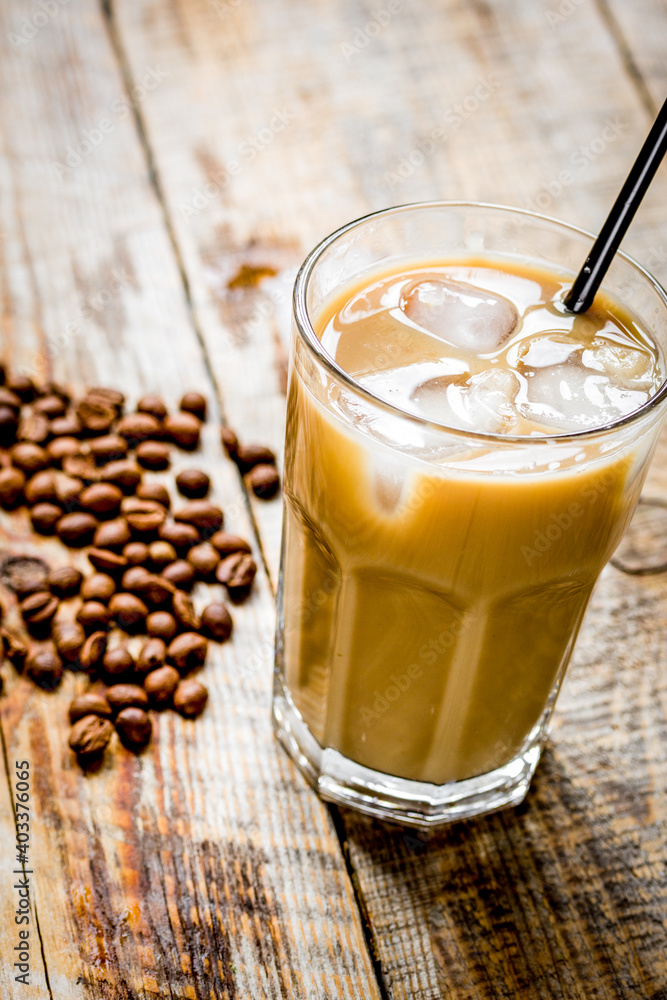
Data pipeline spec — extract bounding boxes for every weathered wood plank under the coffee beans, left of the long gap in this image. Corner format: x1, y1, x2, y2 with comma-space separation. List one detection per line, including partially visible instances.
0, 0, 377, 1000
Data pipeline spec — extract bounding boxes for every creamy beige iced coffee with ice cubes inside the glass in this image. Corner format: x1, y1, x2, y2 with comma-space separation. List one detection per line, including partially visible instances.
281, 258, 664, 785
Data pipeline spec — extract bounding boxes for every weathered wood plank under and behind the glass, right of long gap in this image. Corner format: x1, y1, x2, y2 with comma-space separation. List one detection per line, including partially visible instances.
114, 0, 667, 1000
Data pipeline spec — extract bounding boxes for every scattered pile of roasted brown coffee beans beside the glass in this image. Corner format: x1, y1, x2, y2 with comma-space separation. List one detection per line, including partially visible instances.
0, 365, 280, 765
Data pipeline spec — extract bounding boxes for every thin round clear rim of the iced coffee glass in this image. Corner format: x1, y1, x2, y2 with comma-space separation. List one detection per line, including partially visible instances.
292, 201, 667, 445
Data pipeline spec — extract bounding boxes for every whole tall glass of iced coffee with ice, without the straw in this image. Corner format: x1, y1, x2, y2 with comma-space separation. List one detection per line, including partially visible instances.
274, 203, 667, 826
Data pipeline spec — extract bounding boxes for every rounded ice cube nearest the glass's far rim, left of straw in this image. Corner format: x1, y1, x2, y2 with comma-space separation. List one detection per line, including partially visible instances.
400, 278, 519, 354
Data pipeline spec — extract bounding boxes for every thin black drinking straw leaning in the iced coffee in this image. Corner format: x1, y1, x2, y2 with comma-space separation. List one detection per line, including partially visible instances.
565, 94, 667, 313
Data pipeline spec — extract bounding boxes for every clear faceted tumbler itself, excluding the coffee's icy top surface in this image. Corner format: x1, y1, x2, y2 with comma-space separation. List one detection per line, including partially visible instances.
273, 203, 667, 826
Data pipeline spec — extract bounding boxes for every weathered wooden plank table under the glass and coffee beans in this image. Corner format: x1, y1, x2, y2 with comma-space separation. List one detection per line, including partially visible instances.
0, 0, 667, 1000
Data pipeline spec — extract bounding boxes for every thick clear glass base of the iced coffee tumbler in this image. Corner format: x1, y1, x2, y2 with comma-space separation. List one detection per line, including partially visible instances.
273, 676, 547, 829
